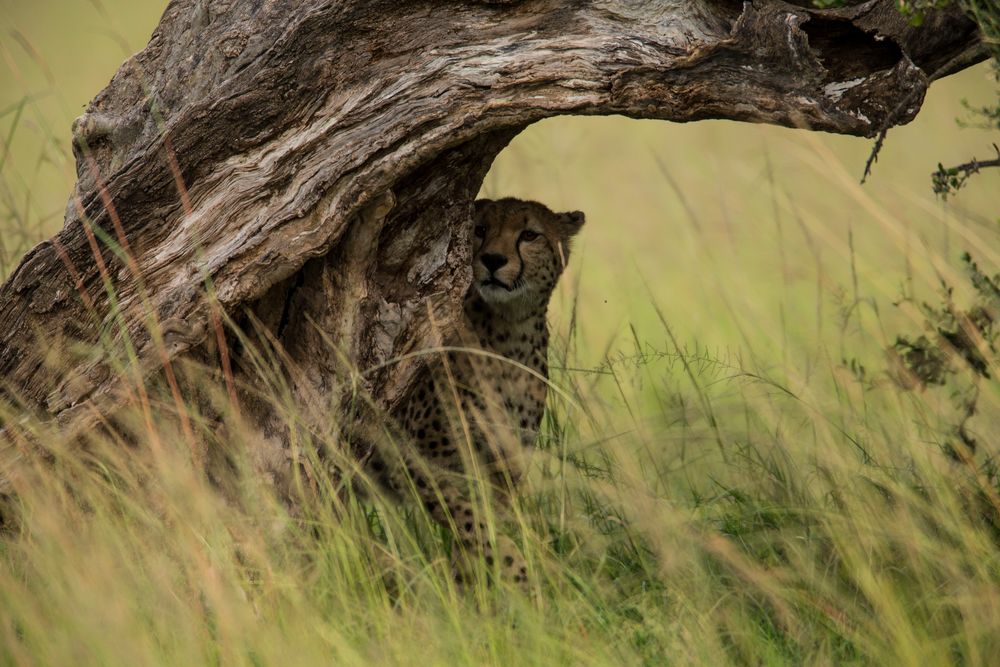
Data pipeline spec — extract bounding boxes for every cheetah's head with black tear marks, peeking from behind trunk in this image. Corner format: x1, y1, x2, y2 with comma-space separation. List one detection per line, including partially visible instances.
473, 199, 584, 304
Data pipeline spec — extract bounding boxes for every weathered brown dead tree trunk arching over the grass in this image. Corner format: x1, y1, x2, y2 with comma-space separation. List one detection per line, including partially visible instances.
0, 0, 984, 448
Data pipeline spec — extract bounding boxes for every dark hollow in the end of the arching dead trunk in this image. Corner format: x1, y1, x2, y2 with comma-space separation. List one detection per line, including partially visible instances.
801, 16, 903, 83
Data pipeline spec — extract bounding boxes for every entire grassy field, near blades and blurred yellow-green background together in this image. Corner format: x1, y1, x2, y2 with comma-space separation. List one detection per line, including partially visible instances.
0, 0, 1000, 665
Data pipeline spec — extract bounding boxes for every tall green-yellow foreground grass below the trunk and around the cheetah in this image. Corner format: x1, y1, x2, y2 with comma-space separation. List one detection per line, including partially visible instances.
0, 248, 1000, 664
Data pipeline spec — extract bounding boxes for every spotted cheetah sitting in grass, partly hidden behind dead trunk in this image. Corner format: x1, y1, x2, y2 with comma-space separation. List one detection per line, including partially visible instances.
370, 198, 584, 588
